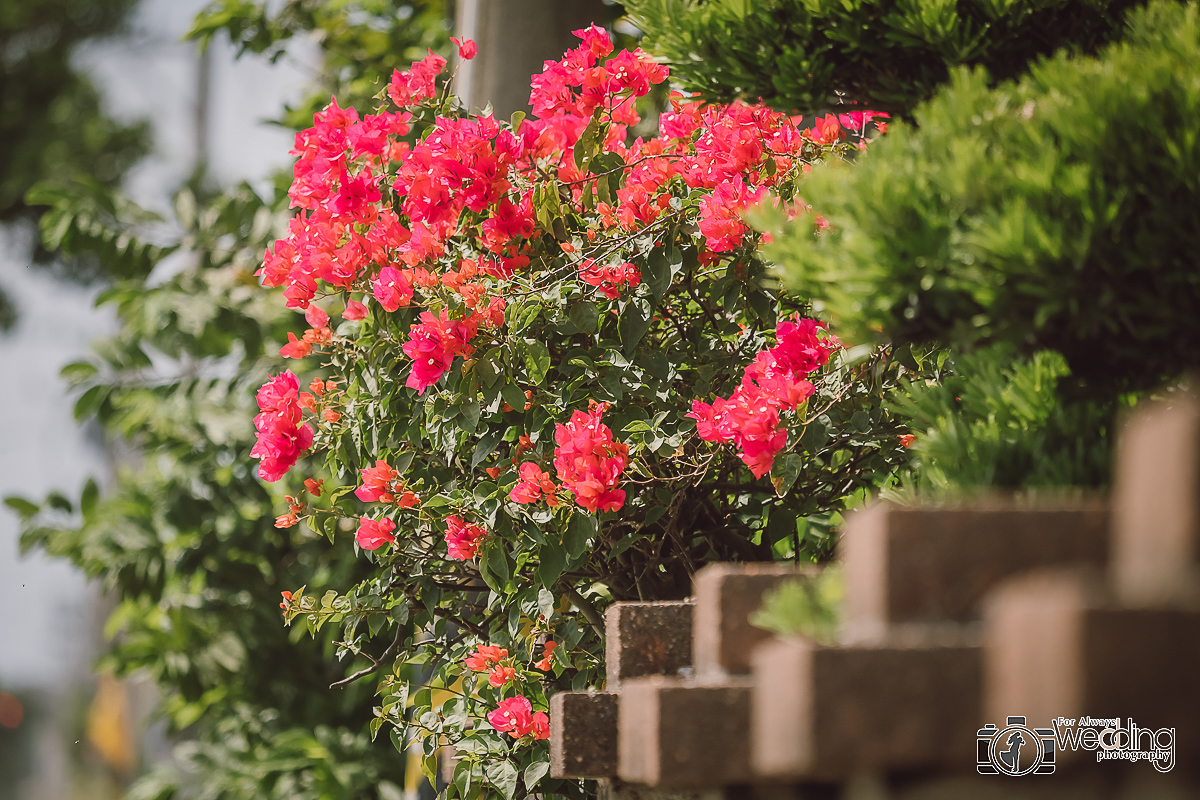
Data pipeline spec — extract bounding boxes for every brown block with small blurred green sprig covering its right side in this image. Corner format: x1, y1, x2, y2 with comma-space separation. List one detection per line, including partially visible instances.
692, 563, 812, 676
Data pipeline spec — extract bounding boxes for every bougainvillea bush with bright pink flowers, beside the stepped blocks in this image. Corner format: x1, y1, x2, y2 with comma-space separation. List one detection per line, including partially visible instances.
253, 28, 914, 798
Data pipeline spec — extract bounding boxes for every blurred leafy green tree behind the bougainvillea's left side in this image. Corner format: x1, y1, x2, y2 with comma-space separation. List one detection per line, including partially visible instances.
6, 2, 445, 800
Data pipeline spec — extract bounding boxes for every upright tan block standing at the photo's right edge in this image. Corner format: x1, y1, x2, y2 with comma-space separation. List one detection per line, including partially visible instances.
1112, 392, 1200, 604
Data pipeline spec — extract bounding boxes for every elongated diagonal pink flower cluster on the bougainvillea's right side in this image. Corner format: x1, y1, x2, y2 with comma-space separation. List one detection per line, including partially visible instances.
688, 319, 840, 477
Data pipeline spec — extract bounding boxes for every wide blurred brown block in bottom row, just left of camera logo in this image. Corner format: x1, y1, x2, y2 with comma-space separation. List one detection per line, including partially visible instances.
750, 636, 983, 780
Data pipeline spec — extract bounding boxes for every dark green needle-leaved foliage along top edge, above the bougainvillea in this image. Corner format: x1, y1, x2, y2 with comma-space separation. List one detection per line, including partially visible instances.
625, 0, 1135, 114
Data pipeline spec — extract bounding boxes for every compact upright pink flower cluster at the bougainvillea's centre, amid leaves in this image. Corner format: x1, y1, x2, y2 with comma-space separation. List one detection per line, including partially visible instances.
554, 403, 629, 512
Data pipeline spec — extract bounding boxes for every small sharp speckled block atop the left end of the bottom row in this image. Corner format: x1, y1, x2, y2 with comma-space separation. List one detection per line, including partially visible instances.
605, 601, 692, 691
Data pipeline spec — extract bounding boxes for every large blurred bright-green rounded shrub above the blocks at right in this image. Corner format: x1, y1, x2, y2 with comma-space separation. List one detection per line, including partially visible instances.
770, 2, 1200, 399
